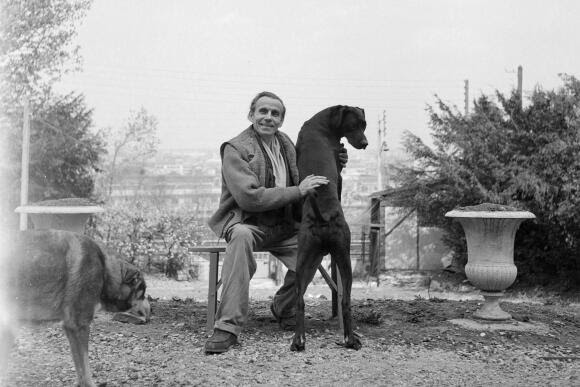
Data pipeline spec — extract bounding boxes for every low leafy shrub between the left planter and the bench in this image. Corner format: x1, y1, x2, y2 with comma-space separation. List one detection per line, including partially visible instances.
87, 200, 203, 277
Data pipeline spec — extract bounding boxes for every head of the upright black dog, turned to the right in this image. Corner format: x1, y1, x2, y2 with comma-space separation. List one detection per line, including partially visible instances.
330, 105, 369, 149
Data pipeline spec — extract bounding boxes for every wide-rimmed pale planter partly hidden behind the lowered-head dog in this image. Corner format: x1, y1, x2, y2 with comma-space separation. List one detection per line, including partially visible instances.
15, 198, 104, 234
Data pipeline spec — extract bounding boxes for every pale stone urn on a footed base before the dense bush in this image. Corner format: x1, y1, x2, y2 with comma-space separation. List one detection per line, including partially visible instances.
445, 203, 535, 321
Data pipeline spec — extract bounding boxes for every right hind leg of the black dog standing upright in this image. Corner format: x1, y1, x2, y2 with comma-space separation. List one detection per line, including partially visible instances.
331, 239, 362, 350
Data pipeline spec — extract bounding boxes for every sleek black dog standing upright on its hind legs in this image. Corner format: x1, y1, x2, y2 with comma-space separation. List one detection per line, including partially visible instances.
290, 106, 368, 351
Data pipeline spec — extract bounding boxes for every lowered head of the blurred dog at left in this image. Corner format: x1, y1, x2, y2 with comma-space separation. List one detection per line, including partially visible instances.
101, 257, 151, 321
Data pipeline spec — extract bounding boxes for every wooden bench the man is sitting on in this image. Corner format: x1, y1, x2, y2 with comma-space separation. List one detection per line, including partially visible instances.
189, 246, 343, 332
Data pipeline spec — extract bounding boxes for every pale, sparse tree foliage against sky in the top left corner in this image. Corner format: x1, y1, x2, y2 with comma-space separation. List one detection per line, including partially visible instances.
0, 0, 91, 108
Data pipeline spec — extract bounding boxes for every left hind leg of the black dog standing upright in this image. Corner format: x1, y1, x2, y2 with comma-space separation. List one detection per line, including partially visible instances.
290, 242, 323, 351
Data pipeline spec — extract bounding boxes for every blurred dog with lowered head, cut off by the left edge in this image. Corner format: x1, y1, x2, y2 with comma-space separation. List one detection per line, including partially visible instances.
0, 230, 150, 386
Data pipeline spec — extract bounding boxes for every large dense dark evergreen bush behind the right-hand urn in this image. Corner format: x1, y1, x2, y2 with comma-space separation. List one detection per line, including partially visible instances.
394, 75, 580, 285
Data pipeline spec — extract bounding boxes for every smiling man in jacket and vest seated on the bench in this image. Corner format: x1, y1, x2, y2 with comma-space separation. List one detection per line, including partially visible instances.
205, 92, 348, 354
